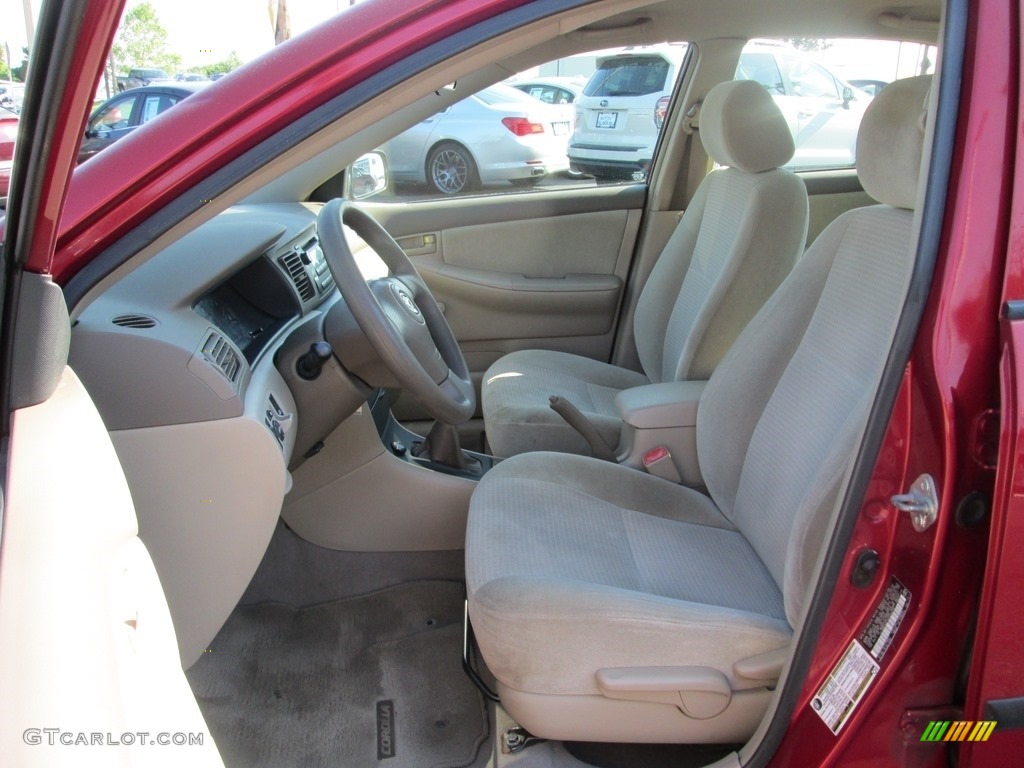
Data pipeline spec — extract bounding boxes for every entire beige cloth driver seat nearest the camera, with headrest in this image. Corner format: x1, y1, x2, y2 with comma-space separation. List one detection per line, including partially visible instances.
466, 78, 930, 743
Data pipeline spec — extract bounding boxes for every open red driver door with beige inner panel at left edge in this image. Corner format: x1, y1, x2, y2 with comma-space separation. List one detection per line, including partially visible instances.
0, 0, 222, 766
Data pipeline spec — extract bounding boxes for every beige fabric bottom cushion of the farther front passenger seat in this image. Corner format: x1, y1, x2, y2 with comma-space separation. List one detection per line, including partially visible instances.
482, 349, 650, 456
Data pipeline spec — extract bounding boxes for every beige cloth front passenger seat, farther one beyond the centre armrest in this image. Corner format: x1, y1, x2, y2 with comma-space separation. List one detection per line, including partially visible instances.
481, 80, 808, 457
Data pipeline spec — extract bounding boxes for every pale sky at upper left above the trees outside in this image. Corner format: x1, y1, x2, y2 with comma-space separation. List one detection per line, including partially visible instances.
0, 0, 358, 68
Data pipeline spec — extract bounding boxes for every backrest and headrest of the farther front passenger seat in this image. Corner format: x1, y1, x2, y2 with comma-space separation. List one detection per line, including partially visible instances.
634, 81, 808, 382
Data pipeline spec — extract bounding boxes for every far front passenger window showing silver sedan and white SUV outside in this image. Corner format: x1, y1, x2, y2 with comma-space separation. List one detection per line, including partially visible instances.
352, 44, 687, 202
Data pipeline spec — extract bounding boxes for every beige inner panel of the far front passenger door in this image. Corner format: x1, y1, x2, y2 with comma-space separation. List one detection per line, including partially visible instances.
362, 184, 646, 419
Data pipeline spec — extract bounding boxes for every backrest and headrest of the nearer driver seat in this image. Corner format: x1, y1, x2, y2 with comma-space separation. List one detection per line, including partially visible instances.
697, 77, 931, 624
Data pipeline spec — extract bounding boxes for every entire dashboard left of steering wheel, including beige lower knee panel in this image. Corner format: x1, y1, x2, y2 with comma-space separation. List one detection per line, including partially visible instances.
69, 203, 366, 667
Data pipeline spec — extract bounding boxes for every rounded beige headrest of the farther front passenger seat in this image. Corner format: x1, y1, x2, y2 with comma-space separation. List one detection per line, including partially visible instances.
700, 80, 795, 173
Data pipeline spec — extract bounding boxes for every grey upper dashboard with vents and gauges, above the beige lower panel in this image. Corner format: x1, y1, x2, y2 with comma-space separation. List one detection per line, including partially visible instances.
70, 204, 336, 462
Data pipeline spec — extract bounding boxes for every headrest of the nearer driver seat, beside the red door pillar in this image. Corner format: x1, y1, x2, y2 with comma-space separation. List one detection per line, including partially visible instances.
857, 75, 932, 210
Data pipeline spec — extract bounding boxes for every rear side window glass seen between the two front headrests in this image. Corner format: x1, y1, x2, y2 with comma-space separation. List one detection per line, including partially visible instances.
735, 38, 936, 171
